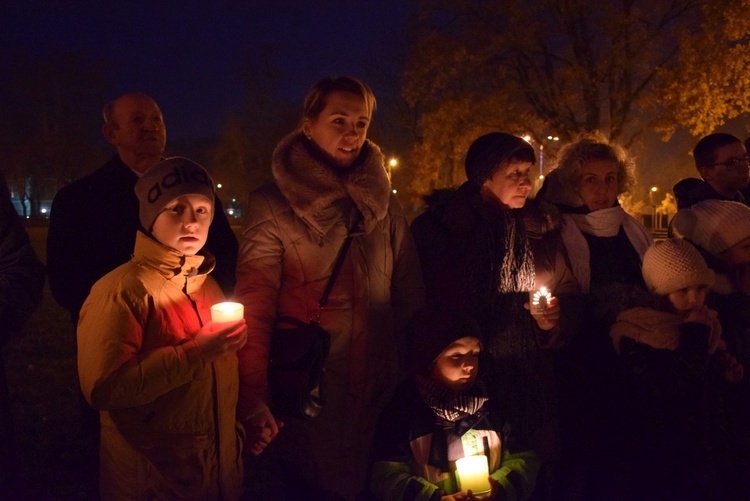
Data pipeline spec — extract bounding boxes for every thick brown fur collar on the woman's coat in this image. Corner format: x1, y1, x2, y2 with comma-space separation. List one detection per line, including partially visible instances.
272, 128, 391, 228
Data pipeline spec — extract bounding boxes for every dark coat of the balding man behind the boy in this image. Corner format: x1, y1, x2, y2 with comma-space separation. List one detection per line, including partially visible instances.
47, 155, 237, 323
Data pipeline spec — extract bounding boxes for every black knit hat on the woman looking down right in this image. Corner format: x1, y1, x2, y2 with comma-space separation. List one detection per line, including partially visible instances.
464, 132, 535, 186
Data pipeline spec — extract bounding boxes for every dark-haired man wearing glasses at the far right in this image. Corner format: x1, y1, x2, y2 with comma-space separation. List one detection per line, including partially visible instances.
673, 133, 750, 209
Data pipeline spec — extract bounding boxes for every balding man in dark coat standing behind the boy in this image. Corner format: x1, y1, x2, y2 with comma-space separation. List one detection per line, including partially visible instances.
47, 93, 237, 326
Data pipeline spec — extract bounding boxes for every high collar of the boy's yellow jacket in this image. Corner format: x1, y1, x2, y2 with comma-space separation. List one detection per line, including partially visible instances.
133, 231, 216, 294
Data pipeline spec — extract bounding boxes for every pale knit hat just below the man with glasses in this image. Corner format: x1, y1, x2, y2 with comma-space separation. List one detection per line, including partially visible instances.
672, 200, 750, 256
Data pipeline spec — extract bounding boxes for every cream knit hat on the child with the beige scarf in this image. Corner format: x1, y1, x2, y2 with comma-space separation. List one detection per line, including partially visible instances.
642, 238, 715, 296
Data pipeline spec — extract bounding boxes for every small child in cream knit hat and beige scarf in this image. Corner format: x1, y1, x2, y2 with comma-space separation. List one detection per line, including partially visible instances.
610, 239, 744, 499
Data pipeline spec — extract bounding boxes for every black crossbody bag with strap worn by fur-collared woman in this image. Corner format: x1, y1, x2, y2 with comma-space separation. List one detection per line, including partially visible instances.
268, 218, 359, 419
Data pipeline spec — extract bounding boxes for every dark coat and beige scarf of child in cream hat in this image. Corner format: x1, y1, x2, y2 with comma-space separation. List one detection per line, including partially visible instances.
612, 308, 726, 499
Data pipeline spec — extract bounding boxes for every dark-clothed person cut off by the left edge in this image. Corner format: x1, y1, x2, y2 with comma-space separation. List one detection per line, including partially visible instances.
0, 175, 44, 497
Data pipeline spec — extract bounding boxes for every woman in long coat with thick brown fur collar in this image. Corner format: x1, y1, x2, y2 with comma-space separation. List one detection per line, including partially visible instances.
236, 77, 424, 499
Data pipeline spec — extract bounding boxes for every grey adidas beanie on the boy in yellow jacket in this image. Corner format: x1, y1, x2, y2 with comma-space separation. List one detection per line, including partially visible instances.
135, 157, 214, 232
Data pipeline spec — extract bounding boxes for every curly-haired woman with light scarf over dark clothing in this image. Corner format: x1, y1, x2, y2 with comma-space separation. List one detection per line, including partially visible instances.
537, 133, 652, 497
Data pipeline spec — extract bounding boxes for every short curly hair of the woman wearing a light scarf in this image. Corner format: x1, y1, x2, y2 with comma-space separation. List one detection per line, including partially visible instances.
555, 131, 635, 196
